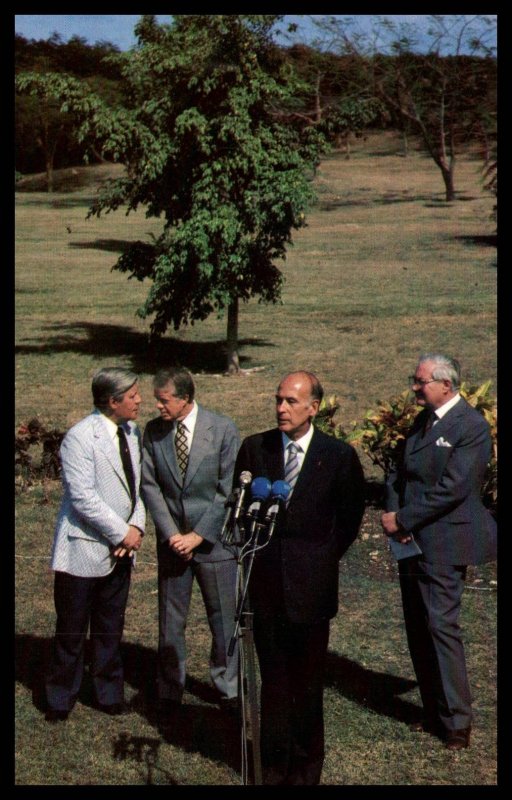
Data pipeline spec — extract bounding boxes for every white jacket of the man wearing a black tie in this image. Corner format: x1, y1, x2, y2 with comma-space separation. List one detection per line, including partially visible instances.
51, 411, 146, 577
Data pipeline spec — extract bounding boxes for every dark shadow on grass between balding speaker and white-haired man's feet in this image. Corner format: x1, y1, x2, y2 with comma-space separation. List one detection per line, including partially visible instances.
325, 651, 422, 724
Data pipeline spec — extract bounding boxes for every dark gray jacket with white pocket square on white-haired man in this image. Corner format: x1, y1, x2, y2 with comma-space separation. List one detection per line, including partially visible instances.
387, 398, 497, 565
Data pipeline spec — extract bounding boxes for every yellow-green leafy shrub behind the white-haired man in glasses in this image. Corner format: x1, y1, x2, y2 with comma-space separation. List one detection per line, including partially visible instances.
315, 381, 498, 516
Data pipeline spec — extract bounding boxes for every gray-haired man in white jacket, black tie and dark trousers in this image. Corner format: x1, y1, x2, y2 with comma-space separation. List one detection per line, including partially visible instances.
46, 367, 146, 722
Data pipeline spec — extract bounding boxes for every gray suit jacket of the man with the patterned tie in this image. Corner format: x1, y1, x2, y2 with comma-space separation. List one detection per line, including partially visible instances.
141, 406, 240, 563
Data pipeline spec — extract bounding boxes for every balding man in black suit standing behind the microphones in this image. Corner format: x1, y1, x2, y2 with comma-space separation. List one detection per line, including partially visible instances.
235, 371, 364, 786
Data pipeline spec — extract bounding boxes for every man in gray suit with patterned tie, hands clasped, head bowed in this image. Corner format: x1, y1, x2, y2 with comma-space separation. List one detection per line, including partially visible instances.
141, 368, 239, 724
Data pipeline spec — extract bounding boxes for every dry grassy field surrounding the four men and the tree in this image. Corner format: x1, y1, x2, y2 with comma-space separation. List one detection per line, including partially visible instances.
15, 135, 497, 786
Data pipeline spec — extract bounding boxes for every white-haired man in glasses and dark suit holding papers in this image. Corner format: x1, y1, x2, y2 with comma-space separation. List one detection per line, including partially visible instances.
381, 353, 497, 750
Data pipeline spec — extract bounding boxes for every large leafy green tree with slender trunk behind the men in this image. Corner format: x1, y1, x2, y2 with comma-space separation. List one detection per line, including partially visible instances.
19, 14, 323, 372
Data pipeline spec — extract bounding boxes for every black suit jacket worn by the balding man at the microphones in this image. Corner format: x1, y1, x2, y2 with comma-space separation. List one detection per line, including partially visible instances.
235, 428, 364, 624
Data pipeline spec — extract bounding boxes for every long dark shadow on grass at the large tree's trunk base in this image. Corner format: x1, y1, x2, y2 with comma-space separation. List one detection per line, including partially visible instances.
15, 321, 275, 374
